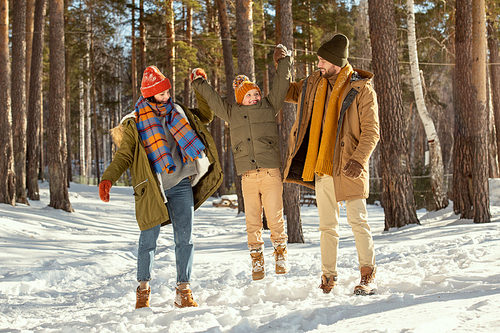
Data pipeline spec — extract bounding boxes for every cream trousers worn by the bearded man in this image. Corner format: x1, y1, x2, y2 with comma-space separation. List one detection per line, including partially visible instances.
315, 175, 375, 277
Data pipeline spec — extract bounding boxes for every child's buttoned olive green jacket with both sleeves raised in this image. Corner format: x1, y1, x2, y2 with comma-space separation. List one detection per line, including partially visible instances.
191, 57, 292, 175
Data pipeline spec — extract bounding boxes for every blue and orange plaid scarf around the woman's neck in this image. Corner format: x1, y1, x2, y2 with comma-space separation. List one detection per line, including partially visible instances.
135, 96, 205, 173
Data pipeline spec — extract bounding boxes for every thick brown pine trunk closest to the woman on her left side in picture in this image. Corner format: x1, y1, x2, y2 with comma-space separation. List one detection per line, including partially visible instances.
48, 0, 73, 212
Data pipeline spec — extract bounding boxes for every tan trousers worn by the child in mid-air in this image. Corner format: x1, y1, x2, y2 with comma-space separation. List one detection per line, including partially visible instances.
241, 168, 288, 250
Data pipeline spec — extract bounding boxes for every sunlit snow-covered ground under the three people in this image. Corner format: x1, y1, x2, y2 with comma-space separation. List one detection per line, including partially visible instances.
0, 180, 500, 333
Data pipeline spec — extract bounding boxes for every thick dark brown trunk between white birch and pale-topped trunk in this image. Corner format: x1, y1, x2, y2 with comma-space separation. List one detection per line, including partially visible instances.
452, 0, 475, 219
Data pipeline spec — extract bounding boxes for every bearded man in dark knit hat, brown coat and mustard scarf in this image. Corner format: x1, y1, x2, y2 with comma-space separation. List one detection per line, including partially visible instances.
283, 34, 380, 295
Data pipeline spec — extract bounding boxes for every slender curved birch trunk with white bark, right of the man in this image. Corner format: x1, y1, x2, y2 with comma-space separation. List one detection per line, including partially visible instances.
406, 0, 448, 210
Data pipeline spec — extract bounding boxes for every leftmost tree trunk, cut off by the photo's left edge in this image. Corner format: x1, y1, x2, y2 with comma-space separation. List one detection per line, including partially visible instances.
0, 0, 16, 206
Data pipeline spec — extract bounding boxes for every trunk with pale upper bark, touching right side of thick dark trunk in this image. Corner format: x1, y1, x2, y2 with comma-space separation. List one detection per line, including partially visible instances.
472, 0, 491, 223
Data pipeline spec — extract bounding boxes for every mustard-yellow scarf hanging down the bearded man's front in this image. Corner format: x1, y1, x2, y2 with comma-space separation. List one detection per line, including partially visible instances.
302, 64, 353, 181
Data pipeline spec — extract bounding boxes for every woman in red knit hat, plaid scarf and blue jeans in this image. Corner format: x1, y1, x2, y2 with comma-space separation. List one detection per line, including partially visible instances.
99, 66, 222, 309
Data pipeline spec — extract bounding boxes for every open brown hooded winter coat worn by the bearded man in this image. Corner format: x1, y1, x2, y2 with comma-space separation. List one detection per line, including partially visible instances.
283, 69, 380, 201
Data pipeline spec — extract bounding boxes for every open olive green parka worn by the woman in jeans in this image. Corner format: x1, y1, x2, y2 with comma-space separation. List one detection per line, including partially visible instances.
102, 99, 223, 230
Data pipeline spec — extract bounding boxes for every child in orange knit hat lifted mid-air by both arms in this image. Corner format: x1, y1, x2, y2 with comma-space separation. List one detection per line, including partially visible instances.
191, 47, 292, 280
